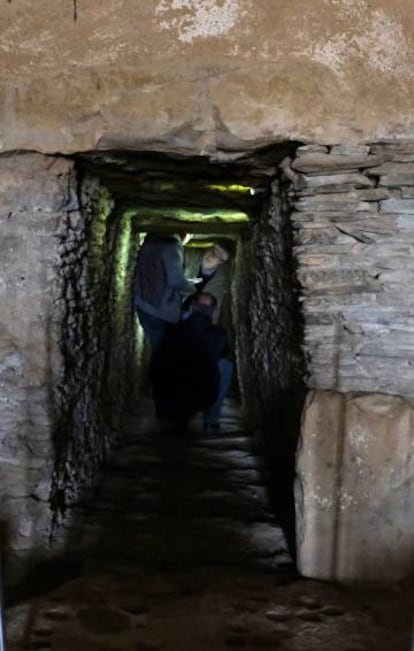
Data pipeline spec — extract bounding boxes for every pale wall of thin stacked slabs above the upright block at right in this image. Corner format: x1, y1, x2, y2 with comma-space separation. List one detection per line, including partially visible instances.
288, 145, 414, 398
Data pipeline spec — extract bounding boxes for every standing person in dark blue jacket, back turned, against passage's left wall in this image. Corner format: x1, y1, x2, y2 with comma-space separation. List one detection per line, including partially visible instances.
134, 233, 195, 350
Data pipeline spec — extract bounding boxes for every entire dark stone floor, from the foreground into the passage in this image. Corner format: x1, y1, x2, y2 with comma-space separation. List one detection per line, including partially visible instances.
7, 406, 412, 651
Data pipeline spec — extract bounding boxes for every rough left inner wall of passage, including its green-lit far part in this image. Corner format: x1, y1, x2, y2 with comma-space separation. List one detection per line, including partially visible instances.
51, 176, 134, 546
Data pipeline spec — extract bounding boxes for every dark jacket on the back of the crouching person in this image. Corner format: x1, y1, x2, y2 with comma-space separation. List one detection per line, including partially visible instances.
152, 314, 228, 420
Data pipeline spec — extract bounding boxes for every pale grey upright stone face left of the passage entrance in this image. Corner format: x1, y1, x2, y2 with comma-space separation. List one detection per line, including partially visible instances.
0, 154, 72, 578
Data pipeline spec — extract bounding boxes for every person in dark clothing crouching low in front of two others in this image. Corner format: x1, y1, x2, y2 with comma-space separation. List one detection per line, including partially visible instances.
152, 292, 233, 431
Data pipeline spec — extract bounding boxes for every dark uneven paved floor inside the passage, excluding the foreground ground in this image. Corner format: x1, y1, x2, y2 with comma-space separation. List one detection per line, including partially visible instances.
63, 400, 291, 571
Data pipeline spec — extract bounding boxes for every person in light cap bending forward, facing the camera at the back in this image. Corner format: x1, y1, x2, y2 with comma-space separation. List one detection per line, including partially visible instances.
184, 240, 231, 324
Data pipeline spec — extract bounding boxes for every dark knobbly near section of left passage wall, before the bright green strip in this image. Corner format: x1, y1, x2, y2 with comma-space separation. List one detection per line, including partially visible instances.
51, 174, 112, 522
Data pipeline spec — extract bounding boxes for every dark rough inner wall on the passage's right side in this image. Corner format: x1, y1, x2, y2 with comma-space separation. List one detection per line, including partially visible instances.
233, 179, 304, 549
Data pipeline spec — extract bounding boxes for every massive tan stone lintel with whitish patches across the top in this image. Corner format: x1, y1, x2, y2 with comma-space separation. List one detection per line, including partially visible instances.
0, 0, 414, 155
